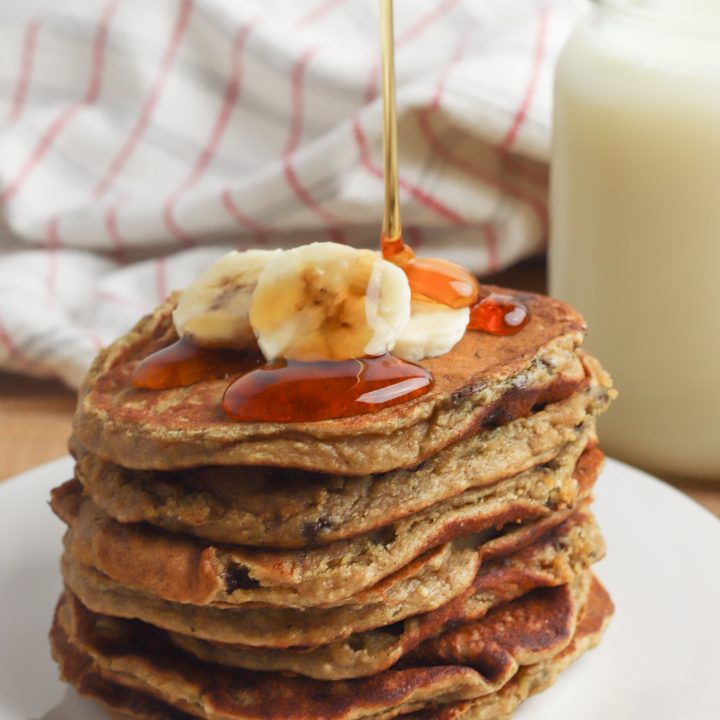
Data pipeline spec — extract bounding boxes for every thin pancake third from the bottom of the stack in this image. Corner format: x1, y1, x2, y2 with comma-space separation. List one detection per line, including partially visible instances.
170, 510, 604, 680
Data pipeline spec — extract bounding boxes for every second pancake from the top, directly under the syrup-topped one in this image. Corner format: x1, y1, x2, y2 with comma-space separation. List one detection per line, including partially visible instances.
73, 366, 609, 549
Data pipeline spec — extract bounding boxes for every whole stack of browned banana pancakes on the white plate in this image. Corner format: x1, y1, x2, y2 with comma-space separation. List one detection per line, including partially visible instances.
51, 290, 614, 720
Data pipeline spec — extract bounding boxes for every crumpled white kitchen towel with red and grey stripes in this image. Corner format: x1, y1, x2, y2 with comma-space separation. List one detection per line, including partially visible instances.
0, 0, 582, 386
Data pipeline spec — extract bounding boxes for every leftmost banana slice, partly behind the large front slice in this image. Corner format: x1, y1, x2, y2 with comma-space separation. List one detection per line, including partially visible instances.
173, 250, 282, 349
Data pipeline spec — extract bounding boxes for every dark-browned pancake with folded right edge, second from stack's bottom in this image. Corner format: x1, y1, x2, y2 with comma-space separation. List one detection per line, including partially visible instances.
51, 575, 590, 720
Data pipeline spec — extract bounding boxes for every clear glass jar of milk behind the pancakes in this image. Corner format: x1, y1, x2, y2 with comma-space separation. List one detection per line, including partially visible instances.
550, 0, 720, 480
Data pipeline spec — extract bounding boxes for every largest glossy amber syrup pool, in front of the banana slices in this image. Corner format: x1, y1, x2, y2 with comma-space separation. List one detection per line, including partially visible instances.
223, 354, 433, 422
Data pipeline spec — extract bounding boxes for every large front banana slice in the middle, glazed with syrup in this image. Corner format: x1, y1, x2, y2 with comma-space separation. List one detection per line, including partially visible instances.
250, 242, 410, 360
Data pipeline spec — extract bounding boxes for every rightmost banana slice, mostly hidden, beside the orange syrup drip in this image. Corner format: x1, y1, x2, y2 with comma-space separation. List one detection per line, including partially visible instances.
393, 300, 470, 362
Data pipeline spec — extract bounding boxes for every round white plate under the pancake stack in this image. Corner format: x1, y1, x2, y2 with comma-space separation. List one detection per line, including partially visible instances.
0, 458, 720, 720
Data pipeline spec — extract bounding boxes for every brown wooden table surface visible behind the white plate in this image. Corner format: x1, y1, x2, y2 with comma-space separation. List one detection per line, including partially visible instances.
0, 261, 720, 517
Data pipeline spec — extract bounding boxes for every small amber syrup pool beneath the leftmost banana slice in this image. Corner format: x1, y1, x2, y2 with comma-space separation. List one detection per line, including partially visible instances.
132, 338, 264, 390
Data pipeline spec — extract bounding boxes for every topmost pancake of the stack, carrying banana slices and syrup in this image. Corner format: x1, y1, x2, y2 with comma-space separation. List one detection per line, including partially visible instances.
74, 286, 586, 475
